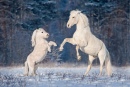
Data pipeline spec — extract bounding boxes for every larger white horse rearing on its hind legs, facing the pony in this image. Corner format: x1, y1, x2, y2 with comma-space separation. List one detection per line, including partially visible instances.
59, 10, 112, 76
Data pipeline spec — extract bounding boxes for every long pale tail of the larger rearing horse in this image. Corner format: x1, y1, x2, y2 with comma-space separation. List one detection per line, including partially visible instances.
105, 51, 112, 76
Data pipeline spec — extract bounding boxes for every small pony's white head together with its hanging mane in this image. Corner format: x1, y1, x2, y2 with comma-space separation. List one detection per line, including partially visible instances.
31, 28, 49, 47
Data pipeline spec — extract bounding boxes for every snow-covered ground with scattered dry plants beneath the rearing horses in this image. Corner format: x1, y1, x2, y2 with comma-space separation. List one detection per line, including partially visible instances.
0, 67, 130, 87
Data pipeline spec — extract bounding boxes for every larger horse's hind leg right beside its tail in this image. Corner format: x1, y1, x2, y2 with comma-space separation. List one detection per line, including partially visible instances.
98, 51, 106, 76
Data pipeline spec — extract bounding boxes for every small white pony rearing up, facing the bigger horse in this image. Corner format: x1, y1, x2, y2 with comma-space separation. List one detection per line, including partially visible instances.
24, 28, 57, 76
